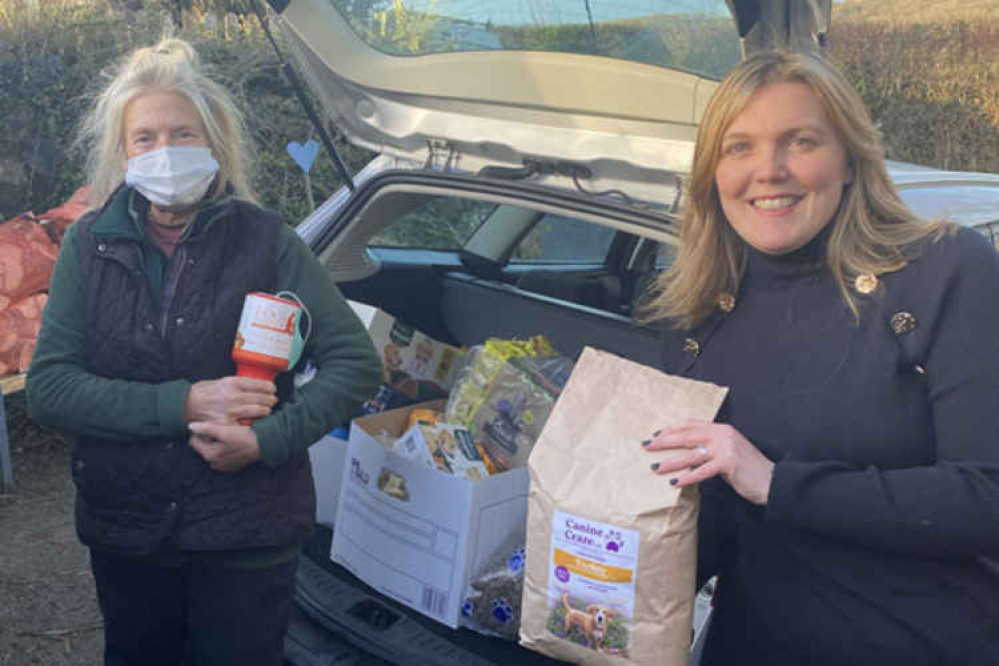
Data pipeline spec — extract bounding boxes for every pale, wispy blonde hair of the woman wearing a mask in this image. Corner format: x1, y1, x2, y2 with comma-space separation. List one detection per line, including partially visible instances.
77, 37, 256, 208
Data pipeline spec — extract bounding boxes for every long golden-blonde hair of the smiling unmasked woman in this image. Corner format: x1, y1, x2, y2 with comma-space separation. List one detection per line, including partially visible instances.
649, 51, 952, 328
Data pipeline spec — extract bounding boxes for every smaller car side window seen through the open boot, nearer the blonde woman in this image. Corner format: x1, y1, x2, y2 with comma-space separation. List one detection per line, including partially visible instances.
511, 215, 615, 264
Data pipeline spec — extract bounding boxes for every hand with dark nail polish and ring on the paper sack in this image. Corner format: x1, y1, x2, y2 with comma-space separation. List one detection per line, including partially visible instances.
642, 420, 774, 504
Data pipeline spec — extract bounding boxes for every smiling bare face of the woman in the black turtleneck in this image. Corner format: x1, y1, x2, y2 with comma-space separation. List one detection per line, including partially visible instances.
715, 78, 851, 255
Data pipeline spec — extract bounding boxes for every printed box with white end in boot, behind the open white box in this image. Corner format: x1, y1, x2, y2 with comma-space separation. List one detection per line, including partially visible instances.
348, 301, 466, 400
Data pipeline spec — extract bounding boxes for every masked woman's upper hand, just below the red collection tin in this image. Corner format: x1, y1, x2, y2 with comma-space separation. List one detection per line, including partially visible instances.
184, 377, 277, 423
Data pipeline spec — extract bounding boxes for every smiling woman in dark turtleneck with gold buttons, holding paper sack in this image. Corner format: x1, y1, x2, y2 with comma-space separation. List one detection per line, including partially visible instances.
644, 53, 999, 666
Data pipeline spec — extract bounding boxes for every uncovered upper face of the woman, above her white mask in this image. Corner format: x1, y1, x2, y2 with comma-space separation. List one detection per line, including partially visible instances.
124, 90, 208, 159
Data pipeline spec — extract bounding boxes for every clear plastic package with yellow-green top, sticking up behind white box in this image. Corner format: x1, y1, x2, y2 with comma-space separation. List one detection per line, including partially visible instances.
447, 336, 572, 471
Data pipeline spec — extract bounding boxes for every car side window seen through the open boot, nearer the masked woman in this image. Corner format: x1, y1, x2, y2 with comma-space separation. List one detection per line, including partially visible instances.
370, 197, 497, 250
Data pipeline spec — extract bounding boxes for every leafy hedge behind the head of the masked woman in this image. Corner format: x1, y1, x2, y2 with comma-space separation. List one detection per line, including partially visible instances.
0, 0, 371, 222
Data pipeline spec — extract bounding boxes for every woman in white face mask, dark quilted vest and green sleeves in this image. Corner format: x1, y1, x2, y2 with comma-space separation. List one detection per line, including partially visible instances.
27, 39, 379, 666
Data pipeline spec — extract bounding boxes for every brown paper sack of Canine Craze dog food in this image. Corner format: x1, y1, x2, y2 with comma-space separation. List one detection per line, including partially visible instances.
520, 348, 727, 666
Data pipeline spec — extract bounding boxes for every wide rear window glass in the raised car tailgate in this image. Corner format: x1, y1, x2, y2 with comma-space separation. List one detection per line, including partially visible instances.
329, 0, 740, 78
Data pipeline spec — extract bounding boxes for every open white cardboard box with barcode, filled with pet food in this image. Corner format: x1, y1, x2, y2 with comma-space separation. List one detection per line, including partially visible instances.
331, 401, 528, 628
